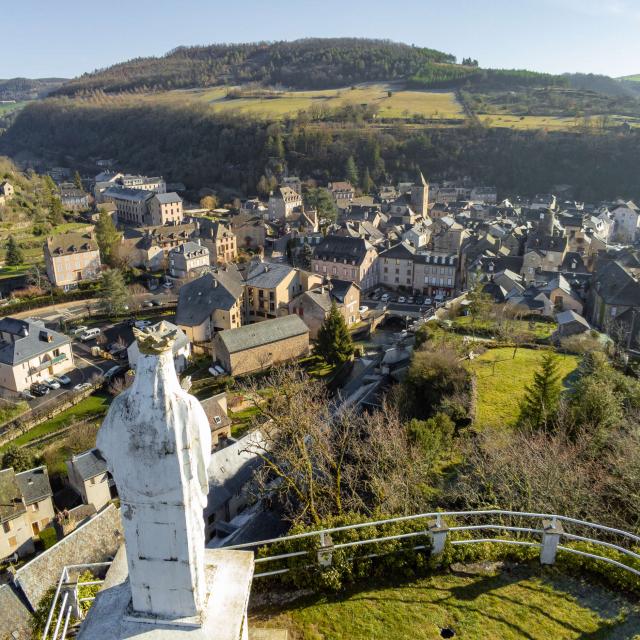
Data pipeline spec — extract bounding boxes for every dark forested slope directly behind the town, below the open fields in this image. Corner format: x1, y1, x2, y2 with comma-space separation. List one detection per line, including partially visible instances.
5, 98, 640, 200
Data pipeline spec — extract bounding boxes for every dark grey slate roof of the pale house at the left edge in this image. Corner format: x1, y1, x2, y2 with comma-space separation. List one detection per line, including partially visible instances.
0, 318, 71, 366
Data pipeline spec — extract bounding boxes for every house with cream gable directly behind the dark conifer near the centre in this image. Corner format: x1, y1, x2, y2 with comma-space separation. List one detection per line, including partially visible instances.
289, 280, 360, 340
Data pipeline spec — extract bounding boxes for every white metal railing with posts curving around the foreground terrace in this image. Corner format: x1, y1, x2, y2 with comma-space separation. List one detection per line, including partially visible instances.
42, 509, 640, 640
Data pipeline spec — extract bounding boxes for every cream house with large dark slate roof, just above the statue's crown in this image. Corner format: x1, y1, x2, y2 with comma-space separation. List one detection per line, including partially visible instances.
176, 268, 244, 348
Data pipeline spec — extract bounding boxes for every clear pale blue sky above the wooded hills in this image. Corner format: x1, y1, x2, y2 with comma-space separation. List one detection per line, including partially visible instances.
0, 0, 640, 78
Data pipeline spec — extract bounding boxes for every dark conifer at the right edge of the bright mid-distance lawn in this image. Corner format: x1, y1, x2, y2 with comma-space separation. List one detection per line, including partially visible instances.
519, 352, 562, 430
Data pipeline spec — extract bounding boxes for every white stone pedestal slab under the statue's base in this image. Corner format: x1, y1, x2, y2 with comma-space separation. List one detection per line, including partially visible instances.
78, 547, 254, 640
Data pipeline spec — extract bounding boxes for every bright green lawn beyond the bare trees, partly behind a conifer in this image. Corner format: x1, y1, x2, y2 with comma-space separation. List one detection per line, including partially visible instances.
471, 347, 579, 428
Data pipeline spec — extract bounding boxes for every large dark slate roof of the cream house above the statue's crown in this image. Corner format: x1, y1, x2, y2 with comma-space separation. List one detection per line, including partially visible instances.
176, 271, 242, 327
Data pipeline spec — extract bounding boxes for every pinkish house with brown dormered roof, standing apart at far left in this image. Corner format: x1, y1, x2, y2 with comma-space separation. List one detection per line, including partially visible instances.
44, 227, 102, 290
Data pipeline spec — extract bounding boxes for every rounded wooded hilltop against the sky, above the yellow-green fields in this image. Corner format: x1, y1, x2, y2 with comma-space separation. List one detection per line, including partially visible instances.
52, 38, 455, 95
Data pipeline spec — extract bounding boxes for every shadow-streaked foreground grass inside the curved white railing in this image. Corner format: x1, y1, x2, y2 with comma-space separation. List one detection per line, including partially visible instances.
251, 567, 640, 640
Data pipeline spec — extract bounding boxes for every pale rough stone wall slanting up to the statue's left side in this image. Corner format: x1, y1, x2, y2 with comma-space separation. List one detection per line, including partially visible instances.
14, 505, 124, 609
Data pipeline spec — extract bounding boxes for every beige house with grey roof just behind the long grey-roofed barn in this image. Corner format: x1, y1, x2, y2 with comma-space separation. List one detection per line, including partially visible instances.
245, 262, 322, 322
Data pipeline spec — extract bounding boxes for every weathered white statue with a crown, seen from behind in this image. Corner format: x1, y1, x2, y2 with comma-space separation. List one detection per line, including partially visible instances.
97, 329, 211, 620
